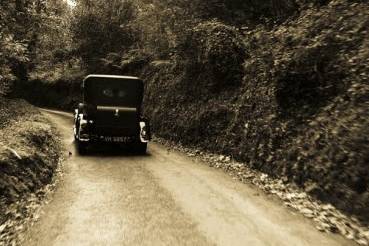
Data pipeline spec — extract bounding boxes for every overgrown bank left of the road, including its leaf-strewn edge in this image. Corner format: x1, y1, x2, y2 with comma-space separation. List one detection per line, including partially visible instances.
0, 100, 62, 245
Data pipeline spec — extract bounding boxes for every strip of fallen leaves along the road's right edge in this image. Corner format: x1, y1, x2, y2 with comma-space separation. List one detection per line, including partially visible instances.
154, 138, 369, 245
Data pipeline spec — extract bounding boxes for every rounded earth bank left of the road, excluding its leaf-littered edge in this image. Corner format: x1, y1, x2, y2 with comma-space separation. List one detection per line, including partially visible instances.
0, 98, 61, 232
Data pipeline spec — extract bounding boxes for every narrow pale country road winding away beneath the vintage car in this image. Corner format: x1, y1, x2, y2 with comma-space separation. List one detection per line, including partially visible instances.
23, 111, 351, 246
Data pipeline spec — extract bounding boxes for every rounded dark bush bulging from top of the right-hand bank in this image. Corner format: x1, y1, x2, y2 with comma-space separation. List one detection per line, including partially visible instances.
177, 20, 246, 91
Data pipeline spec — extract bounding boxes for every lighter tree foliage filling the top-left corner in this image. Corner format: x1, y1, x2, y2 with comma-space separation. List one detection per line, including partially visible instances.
0, 0, 70, 95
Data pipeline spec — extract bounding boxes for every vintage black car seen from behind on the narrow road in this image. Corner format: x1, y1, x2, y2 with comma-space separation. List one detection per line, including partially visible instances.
74, 75, 151, 154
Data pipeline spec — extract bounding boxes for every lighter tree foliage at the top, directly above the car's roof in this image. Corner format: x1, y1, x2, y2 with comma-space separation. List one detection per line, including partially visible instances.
71, 0, 136, 71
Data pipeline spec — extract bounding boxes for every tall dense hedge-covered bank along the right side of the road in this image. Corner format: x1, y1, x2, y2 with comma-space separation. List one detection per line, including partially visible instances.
143, 0, 369, 220
